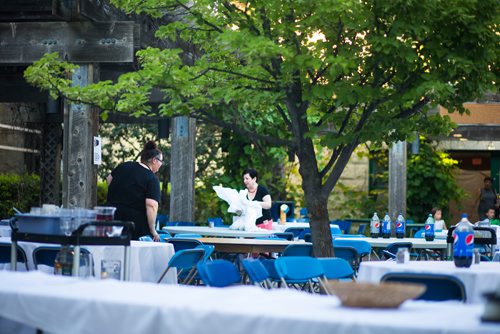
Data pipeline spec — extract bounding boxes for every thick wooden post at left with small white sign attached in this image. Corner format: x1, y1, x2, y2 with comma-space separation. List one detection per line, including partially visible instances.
62, 64, 98, 208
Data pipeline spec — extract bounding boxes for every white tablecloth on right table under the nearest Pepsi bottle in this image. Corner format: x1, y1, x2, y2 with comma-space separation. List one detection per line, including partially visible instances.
358, 261, 500, 303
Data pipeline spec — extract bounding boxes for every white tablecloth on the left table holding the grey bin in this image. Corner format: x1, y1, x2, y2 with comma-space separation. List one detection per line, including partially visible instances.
0, 238, 177, 284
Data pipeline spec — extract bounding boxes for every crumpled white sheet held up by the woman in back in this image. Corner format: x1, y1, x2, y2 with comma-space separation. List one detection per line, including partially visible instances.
213, 186, 262, 231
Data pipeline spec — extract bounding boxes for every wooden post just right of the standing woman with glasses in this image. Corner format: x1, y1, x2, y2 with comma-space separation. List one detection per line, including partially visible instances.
170, 116, 196, 221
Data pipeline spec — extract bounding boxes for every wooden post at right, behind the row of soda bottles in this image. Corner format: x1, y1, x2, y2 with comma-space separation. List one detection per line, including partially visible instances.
389, 141, 406, 222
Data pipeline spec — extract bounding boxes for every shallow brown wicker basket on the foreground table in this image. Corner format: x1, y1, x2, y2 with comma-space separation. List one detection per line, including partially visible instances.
326, 281, 426, 308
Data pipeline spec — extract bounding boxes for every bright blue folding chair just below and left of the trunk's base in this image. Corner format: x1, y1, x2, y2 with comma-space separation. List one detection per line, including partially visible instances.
274, 256, 324, 293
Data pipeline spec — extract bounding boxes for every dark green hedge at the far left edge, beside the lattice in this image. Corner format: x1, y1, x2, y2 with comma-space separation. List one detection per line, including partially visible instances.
0, 173, 40, 218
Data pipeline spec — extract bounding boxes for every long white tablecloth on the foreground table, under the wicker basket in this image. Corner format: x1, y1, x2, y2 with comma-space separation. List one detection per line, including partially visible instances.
0, 272, 499, 334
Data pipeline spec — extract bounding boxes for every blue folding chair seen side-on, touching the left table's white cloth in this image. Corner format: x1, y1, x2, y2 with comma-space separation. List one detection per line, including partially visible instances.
157, 248, 205, 284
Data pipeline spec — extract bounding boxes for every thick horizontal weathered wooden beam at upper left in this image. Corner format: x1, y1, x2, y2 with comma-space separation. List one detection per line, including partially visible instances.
0, 22, 139, 65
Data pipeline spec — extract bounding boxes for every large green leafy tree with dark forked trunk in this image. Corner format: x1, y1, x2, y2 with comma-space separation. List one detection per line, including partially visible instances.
26, 0, 500, 256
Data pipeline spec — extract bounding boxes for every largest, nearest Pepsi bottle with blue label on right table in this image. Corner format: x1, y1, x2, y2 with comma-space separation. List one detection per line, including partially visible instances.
453, 213, 474, 268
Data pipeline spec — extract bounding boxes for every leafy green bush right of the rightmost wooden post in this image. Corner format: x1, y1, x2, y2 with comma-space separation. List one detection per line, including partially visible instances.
407, 141, 465, 221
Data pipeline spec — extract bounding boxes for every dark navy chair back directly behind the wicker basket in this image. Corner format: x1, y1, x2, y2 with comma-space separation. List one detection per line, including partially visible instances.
380, 272, 467, 302
